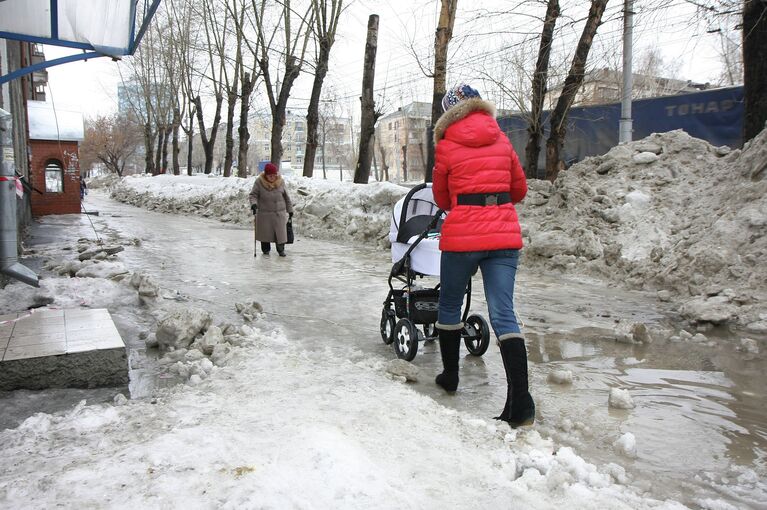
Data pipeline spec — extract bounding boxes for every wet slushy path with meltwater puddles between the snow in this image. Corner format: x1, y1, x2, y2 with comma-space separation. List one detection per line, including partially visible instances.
3, 192, 767, 508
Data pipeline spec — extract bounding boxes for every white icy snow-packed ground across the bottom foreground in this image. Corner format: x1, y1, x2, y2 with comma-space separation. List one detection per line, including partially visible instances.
0, 324, 683, 509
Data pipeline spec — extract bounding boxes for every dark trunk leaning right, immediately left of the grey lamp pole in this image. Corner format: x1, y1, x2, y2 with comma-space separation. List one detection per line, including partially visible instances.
546, 0, 607, 182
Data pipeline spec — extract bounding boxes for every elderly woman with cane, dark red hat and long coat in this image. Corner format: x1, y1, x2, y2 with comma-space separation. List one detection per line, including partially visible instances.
248, 163, 293, 257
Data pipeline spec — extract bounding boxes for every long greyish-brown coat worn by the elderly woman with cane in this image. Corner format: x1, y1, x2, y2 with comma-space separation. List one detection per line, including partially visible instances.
248, 174, 293, 244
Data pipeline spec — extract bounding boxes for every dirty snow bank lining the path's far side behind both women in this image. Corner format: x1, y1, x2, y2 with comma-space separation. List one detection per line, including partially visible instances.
112, 131, 767, 334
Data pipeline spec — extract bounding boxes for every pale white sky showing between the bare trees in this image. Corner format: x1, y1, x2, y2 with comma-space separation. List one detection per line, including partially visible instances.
40, 0, 732, 117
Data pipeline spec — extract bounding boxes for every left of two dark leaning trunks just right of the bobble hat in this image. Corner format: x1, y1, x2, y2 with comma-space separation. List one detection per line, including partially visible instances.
525, 0, 560, 179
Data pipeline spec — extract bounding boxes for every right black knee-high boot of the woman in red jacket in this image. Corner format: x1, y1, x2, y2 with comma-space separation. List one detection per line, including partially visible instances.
495, 337, 535, 428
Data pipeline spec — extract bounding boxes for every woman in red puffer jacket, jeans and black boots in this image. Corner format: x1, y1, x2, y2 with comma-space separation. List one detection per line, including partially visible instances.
432, 84, 535, 428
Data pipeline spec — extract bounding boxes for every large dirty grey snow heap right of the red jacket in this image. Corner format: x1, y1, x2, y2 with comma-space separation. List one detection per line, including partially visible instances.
519, 126, 767, 331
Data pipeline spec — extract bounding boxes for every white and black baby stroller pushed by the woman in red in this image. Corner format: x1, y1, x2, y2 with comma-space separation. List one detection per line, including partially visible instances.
381, 183, 490, 361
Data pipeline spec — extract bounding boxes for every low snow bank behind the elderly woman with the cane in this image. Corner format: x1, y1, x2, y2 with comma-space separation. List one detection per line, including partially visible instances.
112, 175, 408, 247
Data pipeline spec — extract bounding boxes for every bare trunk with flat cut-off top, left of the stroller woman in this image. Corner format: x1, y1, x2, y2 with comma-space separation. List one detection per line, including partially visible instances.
354, 14, 378, 184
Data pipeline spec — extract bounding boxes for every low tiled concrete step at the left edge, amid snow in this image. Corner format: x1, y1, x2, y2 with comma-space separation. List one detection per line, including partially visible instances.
0, 309, 128, 390
